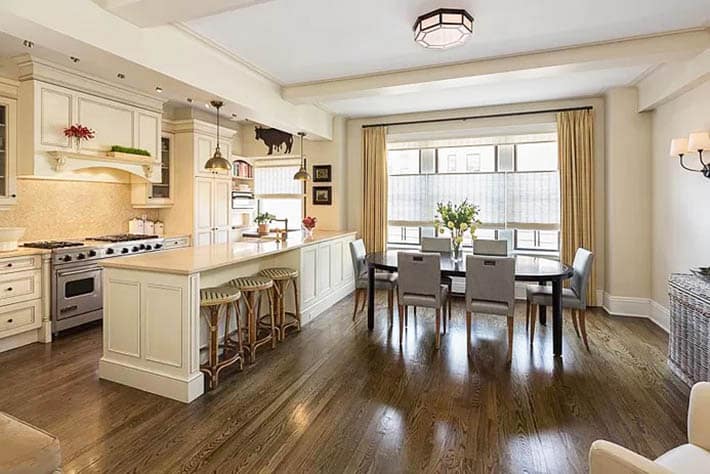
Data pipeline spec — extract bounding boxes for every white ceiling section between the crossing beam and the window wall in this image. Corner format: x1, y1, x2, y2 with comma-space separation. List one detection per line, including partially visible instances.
321, 66, 649, 117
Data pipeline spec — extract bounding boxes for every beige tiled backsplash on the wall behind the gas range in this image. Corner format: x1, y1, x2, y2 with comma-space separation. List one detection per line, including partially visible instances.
0, 179, 158, 241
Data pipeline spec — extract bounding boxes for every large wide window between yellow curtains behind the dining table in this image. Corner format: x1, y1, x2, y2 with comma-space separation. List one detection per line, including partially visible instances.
388, 134, 560, 253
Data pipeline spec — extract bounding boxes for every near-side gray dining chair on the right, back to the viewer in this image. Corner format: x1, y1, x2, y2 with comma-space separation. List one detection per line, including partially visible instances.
466, 255, 515, 362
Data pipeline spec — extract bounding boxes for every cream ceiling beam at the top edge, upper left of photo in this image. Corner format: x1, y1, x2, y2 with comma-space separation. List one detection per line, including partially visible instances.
93, 0, 272, 28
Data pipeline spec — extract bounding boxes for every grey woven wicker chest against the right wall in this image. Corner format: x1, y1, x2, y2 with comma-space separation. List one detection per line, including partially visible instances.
668, 273, 710, 385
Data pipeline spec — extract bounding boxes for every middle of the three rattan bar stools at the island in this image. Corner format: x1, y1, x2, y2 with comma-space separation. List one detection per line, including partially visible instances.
227, 275, 276, 363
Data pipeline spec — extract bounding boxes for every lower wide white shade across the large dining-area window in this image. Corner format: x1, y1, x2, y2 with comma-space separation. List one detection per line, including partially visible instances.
388, 171, 560, 229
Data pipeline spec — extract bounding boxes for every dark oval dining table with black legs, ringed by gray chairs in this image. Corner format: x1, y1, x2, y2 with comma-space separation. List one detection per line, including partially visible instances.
367, 250, 574, 357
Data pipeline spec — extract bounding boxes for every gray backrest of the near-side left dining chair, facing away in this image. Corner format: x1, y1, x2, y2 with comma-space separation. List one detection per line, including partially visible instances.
397, 252, 441, 308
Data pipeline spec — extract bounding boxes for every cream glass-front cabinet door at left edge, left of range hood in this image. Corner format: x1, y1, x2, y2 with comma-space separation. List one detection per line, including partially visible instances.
0, 98, 17, 208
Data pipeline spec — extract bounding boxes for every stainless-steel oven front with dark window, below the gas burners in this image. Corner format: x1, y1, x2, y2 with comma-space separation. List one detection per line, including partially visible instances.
51, 262, 103, 334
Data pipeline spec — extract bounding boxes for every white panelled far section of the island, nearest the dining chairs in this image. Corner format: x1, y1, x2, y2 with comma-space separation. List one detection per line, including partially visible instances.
300, 235, 355, 322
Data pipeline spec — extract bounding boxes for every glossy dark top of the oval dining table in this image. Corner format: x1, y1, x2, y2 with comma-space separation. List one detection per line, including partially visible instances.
367, 250, 573, 281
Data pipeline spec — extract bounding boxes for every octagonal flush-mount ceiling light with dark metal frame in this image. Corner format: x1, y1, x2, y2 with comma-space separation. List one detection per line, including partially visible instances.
414, 8, 473, 49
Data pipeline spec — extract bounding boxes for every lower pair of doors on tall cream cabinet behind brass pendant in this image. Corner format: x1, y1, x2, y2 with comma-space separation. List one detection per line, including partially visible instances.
194, 177, 232, 246
